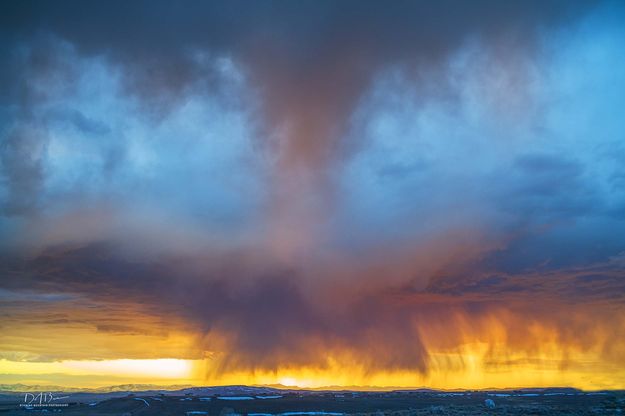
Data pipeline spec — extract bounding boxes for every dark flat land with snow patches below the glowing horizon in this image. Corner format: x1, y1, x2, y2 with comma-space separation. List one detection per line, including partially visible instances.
0, 386, 625, 416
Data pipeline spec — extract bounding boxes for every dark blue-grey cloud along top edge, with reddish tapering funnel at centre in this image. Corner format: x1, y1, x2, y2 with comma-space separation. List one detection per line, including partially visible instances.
2, 1, 594, 168
